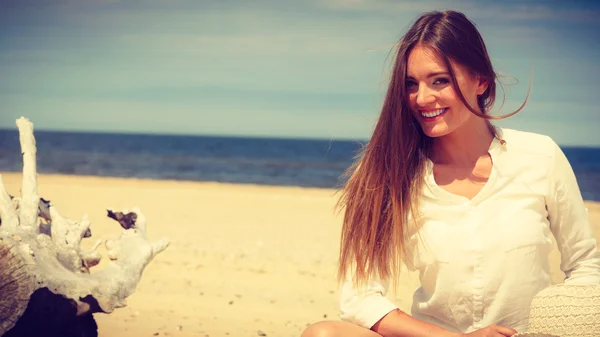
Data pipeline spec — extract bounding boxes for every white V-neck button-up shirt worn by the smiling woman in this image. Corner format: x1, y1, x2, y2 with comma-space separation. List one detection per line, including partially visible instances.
340, 129, 600, 333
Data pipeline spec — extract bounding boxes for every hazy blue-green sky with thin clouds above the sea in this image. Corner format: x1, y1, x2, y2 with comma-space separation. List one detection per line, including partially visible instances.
0, 0, 600, 146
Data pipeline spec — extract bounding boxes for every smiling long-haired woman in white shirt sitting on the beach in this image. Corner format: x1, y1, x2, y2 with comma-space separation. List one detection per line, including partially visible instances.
302, 11, 600, 337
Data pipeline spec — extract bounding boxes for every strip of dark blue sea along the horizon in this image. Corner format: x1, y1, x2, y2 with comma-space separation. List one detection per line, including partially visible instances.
0, 130, 600, 201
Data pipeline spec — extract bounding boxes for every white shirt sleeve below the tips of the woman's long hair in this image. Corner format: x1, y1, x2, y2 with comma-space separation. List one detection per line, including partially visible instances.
340, 274, 398, 329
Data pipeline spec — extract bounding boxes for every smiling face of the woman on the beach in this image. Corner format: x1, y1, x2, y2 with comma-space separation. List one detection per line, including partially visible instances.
406, 45, 487, 137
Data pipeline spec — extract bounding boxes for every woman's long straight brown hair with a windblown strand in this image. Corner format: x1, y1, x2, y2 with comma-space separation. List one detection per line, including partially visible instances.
338, 11, 529, 284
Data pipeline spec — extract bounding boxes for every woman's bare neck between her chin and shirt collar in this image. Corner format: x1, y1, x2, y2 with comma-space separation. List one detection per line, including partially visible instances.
432, 116, 494, 166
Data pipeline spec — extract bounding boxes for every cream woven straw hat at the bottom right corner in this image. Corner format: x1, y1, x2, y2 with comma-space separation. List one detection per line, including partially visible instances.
513, 283, 600, 337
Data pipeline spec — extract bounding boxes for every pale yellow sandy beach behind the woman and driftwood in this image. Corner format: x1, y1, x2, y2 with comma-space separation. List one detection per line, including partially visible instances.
2, 173, 600, 337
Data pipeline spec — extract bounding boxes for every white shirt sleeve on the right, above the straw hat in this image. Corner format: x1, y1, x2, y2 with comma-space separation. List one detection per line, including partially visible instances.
546, 142, 600, 284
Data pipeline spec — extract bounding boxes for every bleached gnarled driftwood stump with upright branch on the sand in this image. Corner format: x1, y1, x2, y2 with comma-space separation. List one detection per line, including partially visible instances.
0, 117, 169, 337
